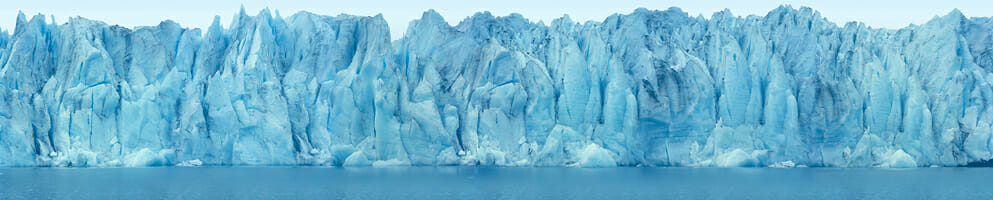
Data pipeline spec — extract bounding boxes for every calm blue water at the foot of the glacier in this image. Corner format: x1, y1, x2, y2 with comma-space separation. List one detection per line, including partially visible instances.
0, 167, 993, 200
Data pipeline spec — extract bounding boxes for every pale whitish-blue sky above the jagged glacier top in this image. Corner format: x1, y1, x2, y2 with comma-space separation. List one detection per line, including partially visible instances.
0, 0, 993, 39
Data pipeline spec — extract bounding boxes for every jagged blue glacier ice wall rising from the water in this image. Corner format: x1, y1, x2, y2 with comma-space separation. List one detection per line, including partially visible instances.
0, 6, 993, 167
